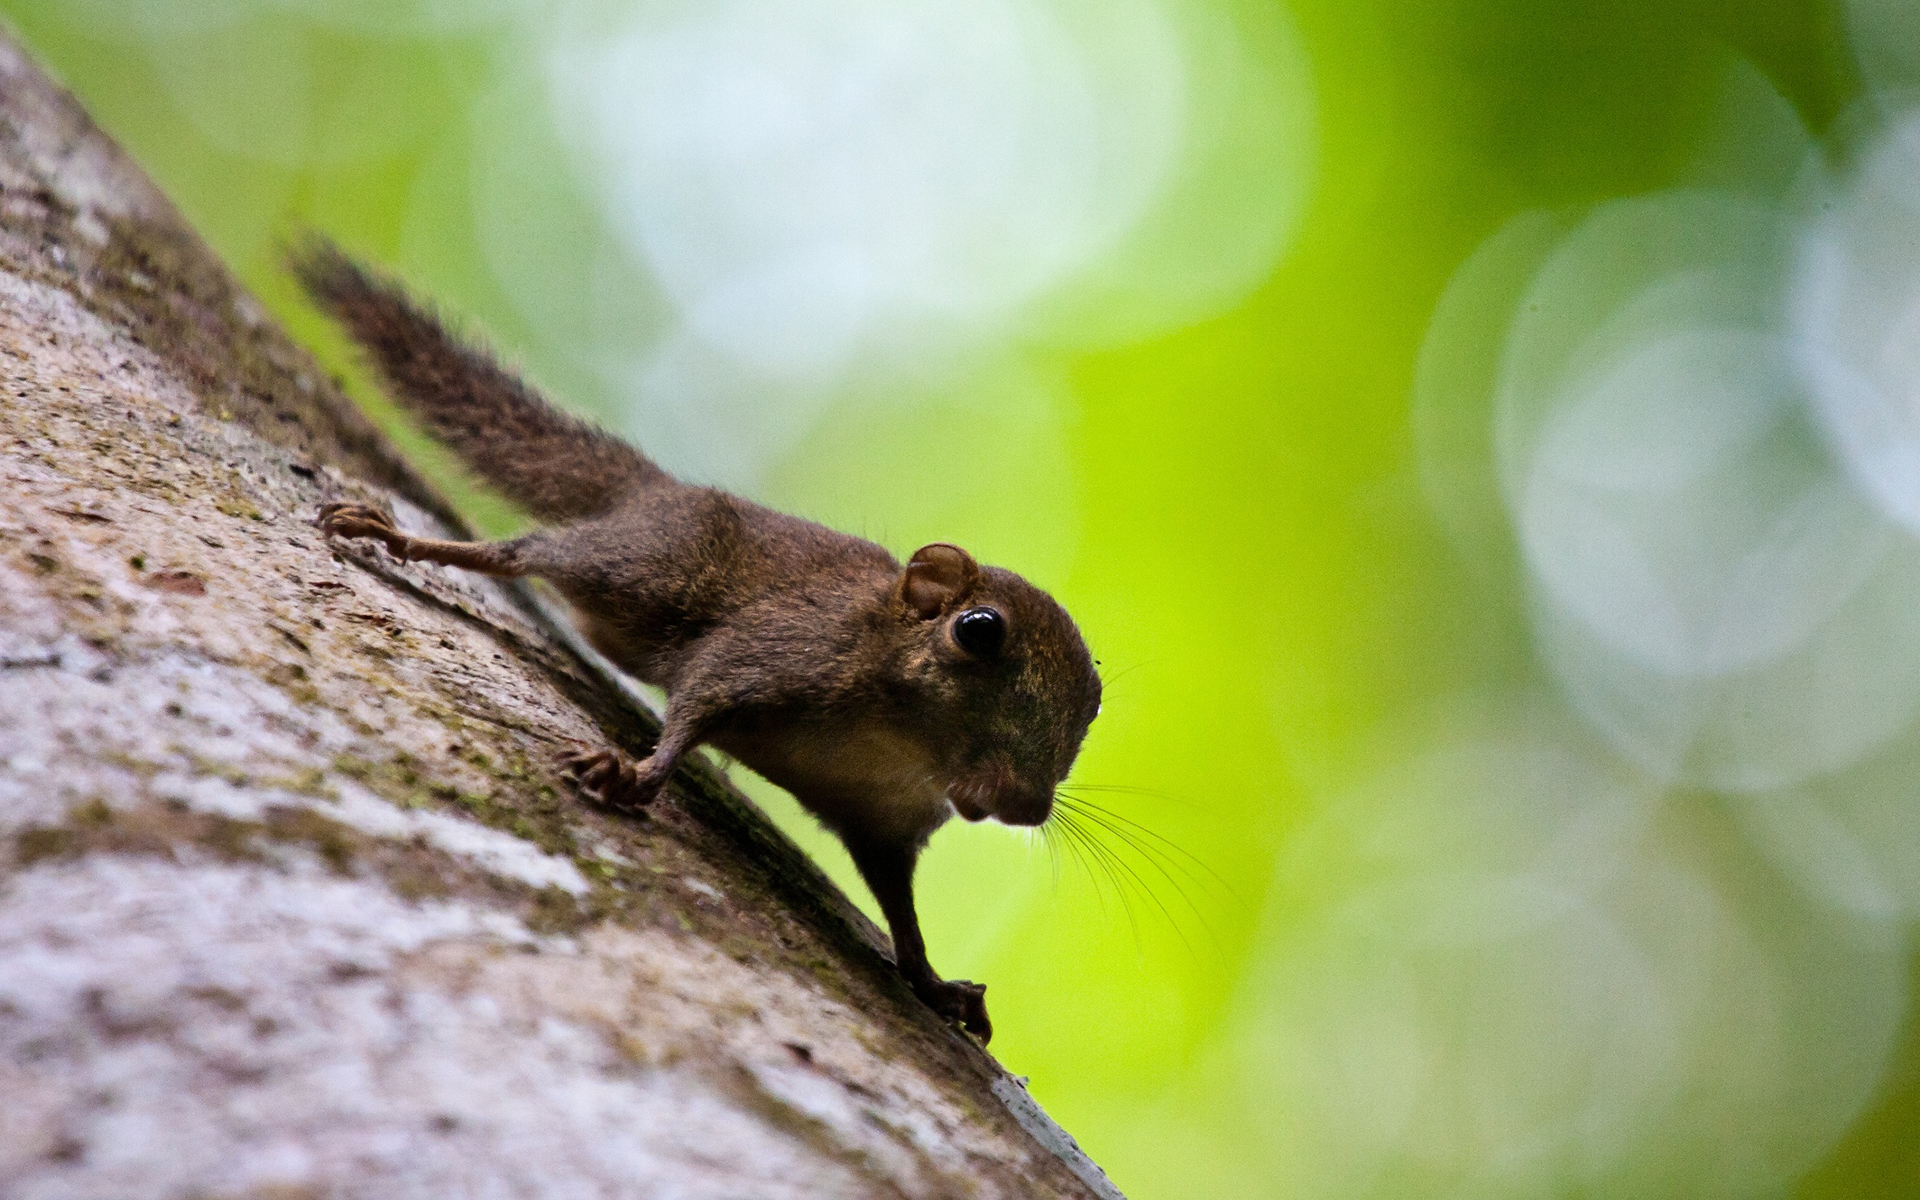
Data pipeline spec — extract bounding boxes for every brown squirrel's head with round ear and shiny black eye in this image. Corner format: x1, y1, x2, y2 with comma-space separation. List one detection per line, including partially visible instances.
893, 541, 1100, 826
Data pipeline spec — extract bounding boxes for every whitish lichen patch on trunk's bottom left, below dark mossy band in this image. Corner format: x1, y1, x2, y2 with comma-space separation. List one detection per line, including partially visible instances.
0, 858, 871, 1198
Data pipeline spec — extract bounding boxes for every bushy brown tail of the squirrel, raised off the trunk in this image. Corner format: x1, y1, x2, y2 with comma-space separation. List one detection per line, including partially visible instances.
288, 234, 668, 520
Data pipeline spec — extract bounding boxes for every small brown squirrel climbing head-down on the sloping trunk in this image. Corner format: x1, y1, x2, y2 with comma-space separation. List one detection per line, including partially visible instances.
292, 238, 1100, 1041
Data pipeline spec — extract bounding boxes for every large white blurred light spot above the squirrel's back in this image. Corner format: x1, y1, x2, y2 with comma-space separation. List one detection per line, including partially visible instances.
551, 0, 1183, 378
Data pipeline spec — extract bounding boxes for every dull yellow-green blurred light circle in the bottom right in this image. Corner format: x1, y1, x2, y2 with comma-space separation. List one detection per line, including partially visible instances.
1235, 714, 1907, 1198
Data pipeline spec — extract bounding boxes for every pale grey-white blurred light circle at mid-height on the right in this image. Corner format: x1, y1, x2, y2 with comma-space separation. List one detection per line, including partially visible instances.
1475, 180, 1920, 793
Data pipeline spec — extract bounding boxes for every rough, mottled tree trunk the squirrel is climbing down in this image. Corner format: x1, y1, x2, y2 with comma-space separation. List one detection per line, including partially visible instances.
0, 30, 1116, 1200
